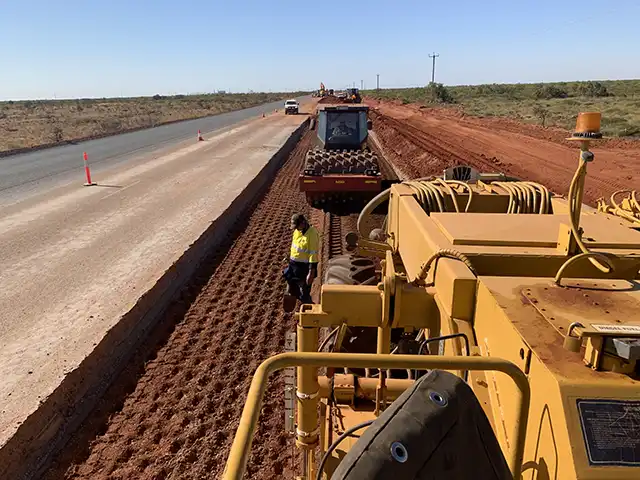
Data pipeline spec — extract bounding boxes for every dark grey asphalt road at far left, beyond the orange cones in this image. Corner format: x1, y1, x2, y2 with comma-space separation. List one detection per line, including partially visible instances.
0, 97, 310, 204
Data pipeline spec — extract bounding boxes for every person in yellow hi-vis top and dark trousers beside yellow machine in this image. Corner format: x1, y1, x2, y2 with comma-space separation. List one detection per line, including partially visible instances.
284, 213, 320, 312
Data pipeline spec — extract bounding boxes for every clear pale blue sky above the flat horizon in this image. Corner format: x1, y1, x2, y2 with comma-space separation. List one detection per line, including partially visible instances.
0, 0, 640, 100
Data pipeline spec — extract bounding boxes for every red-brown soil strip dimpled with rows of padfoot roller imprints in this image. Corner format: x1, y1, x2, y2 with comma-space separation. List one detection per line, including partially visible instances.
48, 132, 313, 480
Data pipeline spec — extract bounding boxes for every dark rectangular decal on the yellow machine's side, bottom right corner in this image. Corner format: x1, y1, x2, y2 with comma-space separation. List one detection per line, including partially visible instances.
577, 399, 640, 467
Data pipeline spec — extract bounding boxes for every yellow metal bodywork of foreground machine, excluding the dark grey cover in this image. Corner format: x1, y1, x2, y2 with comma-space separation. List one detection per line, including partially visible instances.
224, 111, 640, 480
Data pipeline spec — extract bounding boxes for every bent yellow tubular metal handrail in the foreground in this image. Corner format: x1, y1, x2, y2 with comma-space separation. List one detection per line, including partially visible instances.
222, 352, 531, 480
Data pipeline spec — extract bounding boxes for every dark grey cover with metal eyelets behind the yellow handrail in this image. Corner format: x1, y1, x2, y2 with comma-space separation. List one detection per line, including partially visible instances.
331, 370, 512, 480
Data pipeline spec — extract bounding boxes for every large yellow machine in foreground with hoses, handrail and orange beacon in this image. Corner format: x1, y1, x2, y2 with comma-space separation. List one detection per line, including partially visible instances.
223, 113, 640, 480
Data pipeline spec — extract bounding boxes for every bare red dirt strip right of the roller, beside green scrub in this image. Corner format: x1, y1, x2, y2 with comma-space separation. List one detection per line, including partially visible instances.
366, 99, 640, 205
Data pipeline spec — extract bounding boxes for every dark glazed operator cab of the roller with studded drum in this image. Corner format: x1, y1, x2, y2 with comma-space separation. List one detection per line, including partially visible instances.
318, 106, 368, 150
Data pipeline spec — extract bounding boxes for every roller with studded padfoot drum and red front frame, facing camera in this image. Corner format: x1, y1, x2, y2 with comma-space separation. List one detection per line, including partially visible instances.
299, 105, 382, 210
